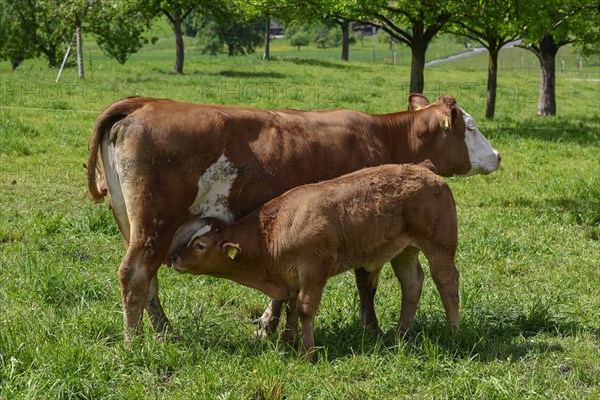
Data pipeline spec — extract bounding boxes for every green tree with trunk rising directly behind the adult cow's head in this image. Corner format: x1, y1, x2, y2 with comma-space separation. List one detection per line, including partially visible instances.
363, 0, 454, 93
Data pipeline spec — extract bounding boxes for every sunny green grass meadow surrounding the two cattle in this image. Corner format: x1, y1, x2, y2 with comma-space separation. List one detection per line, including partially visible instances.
0, 28, 600, 400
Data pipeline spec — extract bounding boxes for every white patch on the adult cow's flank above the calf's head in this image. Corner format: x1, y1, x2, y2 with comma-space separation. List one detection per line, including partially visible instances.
189, 154, 238, 222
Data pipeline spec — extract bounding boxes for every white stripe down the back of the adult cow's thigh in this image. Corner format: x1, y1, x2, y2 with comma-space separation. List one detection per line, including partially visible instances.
100, 130, 131, 243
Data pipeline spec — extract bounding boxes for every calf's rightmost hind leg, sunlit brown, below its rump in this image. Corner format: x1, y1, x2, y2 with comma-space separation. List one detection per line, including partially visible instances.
423, 247, 459, 330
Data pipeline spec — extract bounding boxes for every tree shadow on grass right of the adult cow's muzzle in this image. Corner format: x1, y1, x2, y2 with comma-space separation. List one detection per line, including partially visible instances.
492, 115, 600, 146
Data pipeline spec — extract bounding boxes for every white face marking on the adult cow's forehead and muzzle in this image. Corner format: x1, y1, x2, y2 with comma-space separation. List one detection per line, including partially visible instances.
458, 106, 500, 176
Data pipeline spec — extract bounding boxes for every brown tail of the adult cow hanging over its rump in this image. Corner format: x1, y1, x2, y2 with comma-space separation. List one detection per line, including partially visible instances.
87, 97, 144, 202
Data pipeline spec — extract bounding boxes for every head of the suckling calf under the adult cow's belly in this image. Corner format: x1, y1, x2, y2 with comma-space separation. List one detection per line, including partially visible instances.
167, 218, 241, 275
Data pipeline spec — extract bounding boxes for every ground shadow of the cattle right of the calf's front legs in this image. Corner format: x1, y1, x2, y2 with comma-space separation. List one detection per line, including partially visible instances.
308, 296, 600, 362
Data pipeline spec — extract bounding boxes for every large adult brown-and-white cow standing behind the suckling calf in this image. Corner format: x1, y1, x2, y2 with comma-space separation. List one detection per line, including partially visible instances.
87, 94, 500, 338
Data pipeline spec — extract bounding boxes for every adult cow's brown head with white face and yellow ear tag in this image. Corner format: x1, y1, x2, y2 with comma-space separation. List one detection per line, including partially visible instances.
408, 94, 501, 176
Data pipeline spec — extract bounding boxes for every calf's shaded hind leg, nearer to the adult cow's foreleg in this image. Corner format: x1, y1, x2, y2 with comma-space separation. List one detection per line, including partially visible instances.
392, 248, 423, 336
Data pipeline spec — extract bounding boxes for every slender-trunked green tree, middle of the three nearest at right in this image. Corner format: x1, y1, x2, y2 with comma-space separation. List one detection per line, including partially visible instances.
453, 0, 520, 119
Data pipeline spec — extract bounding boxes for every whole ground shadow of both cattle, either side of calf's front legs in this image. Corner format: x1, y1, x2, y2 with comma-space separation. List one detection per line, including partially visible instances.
165, 296, 600, 363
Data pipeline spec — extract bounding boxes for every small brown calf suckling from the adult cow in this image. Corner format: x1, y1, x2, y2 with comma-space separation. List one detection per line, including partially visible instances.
172, 164, 459, 358
